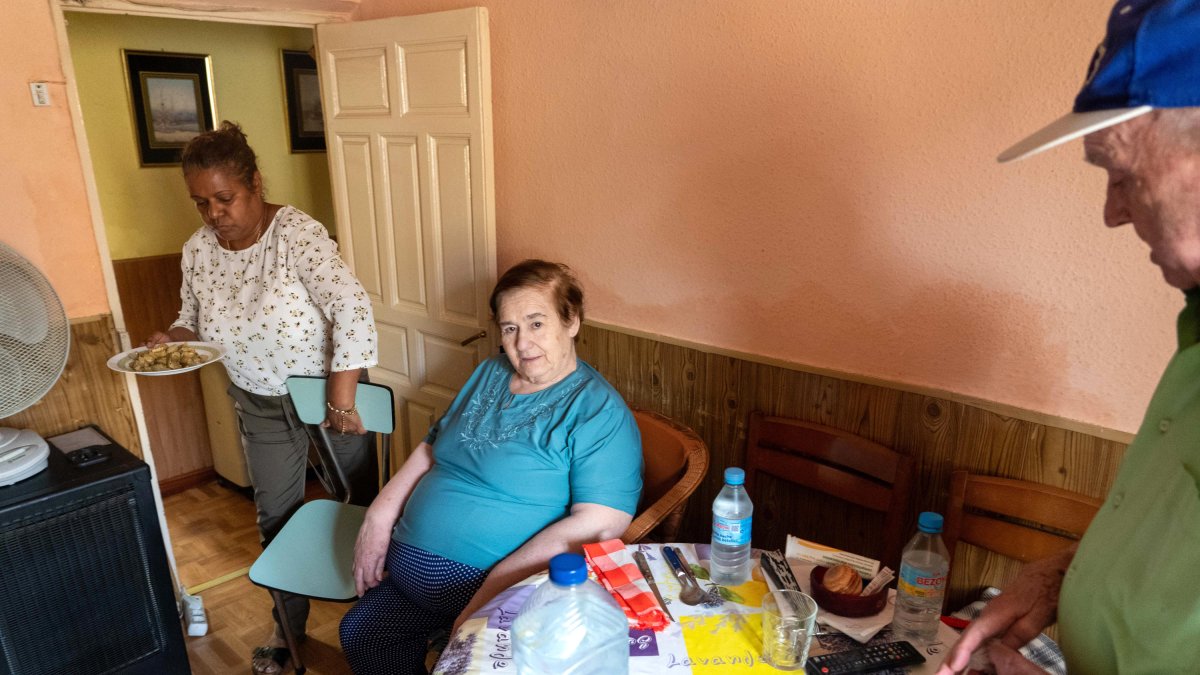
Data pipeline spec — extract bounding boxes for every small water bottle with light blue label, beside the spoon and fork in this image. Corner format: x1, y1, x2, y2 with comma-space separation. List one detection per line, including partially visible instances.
708, 466, 754, 586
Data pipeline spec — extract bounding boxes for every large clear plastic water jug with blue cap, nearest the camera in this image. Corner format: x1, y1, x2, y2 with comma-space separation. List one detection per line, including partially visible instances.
512, 554, 629, 675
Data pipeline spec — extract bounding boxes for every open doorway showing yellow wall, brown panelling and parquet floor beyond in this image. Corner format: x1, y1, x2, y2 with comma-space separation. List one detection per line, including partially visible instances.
64, 11, 344, 673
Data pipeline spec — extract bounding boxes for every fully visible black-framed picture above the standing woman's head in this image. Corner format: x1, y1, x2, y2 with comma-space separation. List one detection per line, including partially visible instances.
121, 49, 216, 166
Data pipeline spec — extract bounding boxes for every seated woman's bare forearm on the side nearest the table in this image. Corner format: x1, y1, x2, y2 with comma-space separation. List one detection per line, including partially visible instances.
454, 503, 634, 631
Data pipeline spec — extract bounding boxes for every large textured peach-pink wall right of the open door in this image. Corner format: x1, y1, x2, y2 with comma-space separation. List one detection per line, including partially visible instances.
356, 0, 1182, 431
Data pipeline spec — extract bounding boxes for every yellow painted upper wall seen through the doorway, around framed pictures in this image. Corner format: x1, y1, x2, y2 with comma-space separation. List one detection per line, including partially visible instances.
67, 12, 334, 259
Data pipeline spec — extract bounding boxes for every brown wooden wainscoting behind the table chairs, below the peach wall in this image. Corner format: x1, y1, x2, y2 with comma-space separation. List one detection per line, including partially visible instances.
578, 324, 1126, 604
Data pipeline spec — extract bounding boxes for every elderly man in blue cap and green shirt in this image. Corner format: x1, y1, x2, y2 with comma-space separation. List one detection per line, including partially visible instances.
938, 0, 1200, 675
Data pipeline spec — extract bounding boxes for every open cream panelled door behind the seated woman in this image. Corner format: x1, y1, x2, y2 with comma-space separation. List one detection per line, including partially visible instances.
317, 7, 496, 471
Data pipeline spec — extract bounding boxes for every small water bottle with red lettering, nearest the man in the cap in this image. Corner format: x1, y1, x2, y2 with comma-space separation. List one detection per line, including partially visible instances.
892, 510, 950, 644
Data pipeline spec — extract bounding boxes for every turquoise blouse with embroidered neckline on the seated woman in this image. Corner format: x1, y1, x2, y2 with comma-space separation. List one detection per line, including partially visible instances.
392, 354, 642, 569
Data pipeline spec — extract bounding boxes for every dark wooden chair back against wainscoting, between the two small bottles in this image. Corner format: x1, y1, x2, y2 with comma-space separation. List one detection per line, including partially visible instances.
745, 412, 913, 569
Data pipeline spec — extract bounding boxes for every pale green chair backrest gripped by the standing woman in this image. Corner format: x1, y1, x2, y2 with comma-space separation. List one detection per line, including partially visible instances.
286, 375, 396, 502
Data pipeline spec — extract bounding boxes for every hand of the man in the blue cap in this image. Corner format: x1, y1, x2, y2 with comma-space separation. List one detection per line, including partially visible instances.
937, 546, 1075, 675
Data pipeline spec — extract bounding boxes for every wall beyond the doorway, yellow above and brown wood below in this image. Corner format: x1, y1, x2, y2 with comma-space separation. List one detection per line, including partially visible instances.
65, 12, 334, 492
